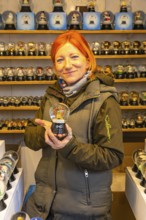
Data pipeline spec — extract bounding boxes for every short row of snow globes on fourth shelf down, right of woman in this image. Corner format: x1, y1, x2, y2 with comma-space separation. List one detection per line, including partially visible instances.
119, 91, 146, 106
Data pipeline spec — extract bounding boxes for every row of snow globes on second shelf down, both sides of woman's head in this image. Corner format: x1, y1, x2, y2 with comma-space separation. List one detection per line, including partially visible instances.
0, 40, 146, 56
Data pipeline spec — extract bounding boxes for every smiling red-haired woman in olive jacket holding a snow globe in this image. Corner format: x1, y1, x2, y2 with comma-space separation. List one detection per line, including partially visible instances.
23, 31, 123, 220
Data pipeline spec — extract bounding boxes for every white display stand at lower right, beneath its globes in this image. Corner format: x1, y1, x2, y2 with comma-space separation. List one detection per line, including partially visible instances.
125, 167, 146, 220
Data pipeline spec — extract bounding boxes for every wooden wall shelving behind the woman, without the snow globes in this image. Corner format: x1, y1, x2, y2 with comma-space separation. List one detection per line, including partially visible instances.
0, 30, 146, 146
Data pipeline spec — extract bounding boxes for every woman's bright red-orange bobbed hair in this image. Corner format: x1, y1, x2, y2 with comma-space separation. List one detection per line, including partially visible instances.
51, 30, 96, 72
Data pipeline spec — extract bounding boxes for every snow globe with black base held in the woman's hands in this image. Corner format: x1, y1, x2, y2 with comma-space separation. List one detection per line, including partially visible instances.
49, 103, 70, 140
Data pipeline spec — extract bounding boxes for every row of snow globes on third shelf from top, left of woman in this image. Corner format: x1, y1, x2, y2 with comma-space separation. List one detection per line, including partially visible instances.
0, 66, 55, 81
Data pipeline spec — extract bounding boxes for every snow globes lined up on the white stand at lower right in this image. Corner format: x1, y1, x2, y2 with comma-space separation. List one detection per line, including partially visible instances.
132, 146, 146, 193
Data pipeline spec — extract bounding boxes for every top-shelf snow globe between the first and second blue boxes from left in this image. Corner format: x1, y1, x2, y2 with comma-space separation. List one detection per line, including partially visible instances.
36, 11, 49, 30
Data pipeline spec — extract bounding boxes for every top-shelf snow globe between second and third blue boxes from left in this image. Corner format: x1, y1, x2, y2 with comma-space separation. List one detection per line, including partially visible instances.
67, 11, 82, 30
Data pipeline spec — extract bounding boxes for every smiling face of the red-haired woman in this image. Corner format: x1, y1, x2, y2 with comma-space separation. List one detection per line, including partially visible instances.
55, 42, 89, 85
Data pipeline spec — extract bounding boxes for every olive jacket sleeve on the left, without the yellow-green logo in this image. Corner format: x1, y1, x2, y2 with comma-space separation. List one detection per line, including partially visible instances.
24, 97, 47, 151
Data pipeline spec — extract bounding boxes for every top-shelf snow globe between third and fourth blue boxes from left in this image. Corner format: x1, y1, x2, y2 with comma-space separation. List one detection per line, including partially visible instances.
101, 11, 114, 30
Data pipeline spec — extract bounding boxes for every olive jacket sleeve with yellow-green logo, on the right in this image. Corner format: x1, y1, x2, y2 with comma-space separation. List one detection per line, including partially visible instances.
59, 97, 123, 171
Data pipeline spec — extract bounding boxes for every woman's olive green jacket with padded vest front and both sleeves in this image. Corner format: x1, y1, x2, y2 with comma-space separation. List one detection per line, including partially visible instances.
25, 75, 123, 219
